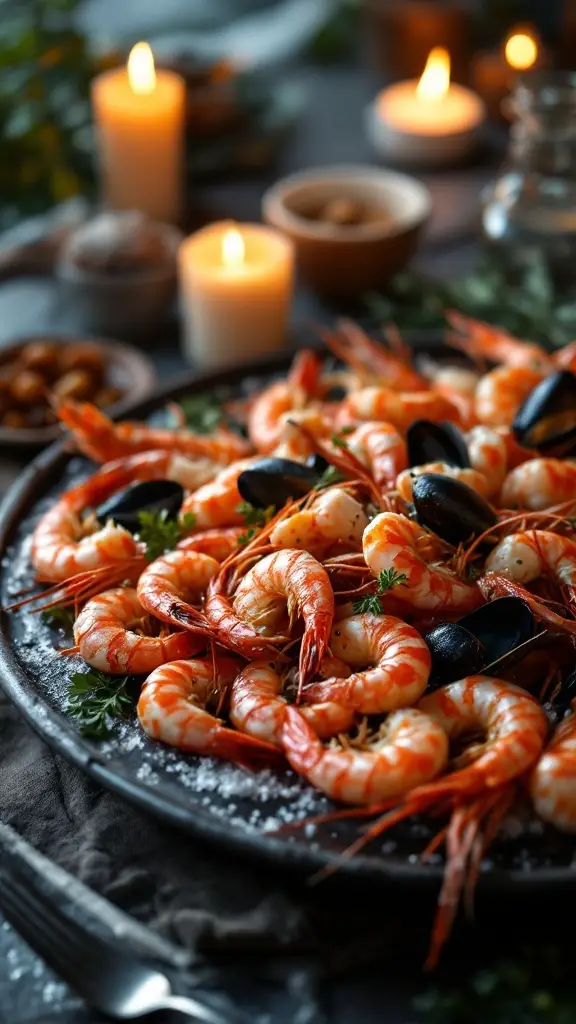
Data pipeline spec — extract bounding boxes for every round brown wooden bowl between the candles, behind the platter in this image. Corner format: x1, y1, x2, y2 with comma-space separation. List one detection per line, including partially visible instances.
262, 166, 431, 299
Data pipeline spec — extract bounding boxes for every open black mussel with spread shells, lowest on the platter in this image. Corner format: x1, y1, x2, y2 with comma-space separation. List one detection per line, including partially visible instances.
424, 597, 534, 689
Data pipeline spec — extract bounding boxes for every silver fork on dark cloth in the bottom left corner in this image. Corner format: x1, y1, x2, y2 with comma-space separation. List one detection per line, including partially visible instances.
0, 863, 247, 1024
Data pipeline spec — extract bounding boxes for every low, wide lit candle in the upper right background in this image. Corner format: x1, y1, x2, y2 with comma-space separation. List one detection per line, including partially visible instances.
367, 46, 485, 164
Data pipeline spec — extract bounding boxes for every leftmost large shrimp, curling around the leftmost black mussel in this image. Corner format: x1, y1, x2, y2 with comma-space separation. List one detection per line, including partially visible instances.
30, 452, 201, 583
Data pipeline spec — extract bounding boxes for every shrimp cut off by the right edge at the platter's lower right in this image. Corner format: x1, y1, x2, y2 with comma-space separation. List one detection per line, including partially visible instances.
529, 702, 576, 833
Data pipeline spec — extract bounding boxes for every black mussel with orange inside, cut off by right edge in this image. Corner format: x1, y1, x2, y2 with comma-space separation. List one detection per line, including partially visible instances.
512, 370, 576, 456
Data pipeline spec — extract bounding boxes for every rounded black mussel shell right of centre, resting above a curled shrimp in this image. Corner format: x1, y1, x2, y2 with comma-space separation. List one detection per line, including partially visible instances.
412, 473, 497, 545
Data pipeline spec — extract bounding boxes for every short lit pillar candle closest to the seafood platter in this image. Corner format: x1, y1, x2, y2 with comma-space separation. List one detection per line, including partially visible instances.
178, 222, 294, 369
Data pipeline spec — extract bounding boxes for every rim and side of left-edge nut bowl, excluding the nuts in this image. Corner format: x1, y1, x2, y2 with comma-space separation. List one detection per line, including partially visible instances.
0, 333, 157, 451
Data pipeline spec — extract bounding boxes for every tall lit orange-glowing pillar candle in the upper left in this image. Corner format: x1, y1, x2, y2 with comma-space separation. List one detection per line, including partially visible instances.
92, 43, 186, 223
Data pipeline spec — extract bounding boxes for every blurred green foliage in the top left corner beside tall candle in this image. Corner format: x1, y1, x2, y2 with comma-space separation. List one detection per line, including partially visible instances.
0, 0, 95, 227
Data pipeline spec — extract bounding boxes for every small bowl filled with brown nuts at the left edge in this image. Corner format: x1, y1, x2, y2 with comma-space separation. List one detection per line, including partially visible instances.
0, 335, 156, 447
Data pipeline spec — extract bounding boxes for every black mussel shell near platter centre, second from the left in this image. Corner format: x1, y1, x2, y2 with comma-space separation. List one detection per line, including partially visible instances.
238, 458, 319, 509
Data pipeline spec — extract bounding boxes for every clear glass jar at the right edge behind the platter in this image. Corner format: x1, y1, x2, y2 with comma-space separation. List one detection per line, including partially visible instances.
482, 71, 576, 287
